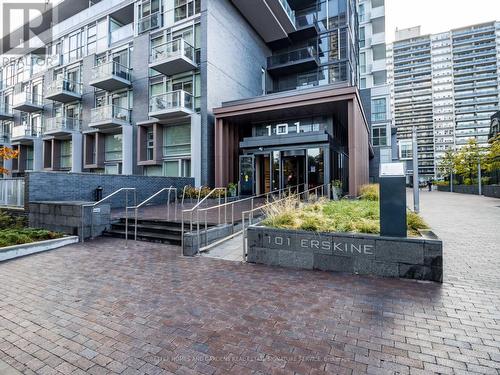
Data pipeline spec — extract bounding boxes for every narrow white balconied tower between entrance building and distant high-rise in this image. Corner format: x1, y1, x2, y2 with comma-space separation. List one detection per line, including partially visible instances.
358, 0, 396, 182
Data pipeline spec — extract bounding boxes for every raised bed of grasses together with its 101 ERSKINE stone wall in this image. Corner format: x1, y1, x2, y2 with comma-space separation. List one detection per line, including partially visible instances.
247, 186, 442, 282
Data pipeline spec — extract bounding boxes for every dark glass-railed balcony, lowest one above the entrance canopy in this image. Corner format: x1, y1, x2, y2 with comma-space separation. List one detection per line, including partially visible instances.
267, 47, 319, 75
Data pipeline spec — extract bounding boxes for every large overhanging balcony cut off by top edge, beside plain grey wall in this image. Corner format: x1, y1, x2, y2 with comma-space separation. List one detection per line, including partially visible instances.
232, 0, 297, 43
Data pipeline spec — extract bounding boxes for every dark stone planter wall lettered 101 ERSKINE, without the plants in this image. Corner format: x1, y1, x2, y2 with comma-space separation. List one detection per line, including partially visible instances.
247, 226, 443, 282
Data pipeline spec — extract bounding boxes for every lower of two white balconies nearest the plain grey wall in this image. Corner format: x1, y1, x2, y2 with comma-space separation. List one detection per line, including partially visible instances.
149, 90, 194, 120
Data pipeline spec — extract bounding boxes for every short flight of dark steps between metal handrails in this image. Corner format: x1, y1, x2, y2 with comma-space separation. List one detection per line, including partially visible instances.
103, 218, 188, 246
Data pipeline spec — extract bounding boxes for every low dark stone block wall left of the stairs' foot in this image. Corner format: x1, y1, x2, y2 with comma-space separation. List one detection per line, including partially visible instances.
28, 202, 111, 238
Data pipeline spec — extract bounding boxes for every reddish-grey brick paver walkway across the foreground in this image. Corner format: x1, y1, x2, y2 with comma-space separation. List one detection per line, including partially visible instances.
0, 192, 500, 375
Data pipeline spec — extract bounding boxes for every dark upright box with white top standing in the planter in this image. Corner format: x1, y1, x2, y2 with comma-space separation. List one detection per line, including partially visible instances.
380, 163, 407, 237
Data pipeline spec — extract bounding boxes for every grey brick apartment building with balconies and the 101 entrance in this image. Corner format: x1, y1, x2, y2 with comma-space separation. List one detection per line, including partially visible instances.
0, 0, 370, 197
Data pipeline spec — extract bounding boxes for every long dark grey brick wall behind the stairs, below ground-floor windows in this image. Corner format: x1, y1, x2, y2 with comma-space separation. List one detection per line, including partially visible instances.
25, 172, 194, 209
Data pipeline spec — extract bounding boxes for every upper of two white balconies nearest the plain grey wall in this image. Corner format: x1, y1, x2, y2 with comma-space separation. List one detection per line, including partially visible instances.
149, 39, 197, 76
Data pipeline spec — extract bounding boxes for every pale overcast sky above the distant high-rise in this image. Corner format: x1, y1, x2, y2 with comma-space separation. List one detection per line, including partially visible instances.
385, 0, 500, 43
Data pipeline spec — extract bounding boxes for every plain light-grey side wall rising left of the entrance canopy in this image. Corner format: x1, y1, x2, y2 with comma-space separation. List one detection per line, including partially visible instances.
201, 0, 271, 185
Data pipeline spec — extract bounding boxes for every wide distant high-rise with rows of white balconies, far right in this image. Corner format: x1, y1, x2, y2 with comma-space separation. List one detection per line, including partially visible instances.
390, 22, 500, 179
